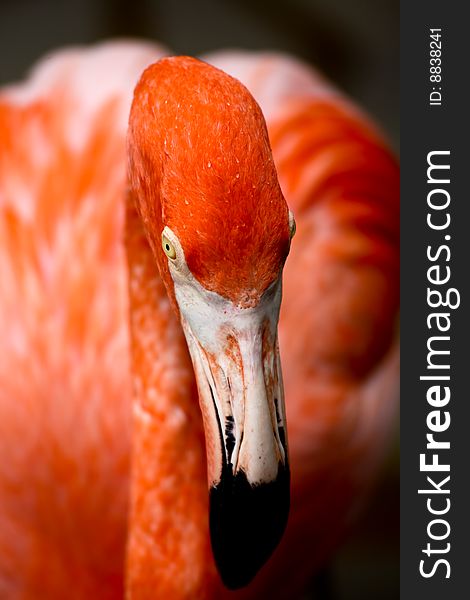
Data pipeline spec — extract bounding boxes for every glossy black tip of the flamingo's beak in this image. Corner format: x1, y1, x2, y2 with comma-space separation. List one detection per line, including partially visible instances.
209, 465, 290, 590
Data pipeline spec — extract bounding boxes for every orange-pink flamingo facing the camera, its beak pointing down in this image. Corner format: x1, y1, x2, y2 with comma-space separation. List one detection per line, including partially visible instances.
0, 42, 398, 600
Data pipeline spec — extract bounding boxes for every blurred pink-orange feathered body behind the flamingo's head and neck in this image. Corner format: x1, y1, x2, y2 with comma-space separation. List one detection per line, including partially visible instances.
0, 2, 398, 598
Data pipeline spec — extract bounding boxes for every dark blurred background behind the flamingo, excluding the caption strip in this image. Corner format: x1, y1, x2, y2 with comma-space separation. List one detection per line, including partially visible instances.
0, 0, 399, 600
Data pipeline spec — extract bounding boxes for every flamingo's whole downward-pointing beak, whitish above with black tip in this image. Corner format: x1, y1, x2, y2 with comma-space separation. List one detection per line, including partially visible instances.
176, 278, 289, 589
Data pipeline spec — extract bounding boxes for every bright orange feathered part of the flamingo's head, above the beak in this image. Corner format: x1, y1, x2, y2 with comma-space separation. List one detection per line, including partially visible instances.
128, 57, 289, 306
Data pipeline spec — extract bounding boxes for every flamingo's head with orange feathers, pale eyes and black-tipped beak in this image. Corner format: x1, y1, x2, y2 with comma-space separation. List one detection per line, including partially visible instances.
128, 57, 295, 588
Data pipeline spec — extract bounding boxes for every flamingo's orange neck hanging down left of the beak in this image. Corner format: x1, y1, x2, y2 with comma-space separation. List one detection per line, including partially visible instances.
126, 198, 217, 598
